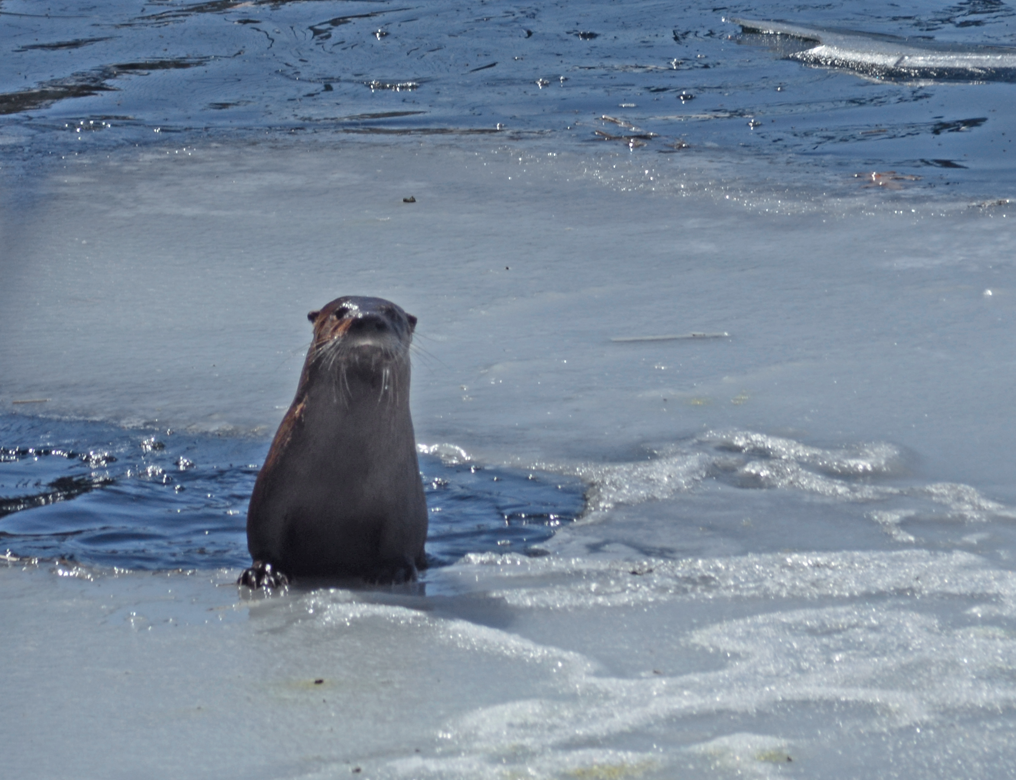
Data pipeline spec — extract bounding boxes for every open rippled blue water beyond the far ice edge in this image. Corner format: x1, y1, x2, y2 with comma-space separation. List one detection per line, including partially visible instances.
0, 0, 1016, 196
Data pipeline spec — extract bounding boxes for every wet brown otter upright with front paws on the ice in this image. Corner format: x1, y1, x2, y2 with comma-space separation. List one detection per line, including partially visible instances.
240, 296, 427, 587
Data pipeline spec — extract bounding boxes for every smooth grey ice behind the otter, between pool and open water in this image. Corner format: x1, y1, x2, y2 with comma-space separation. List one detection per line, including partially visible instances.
0, 142, 1014, 483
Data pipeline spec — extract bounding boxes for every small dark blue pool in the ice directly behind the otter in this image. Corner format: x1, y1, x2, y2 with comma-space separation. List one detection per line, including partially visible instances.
0, 414, 583, 570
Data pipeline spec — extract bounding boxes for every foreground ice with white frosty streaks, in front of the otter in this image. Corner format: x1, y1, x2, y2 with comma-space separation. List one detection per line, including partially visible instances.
7, 550, 1016, 777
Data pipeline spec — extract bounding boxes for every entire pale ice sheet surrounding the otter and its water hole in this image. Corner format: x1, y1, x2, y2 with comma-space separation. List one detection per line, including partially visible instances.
0, 140, 1016, 778
